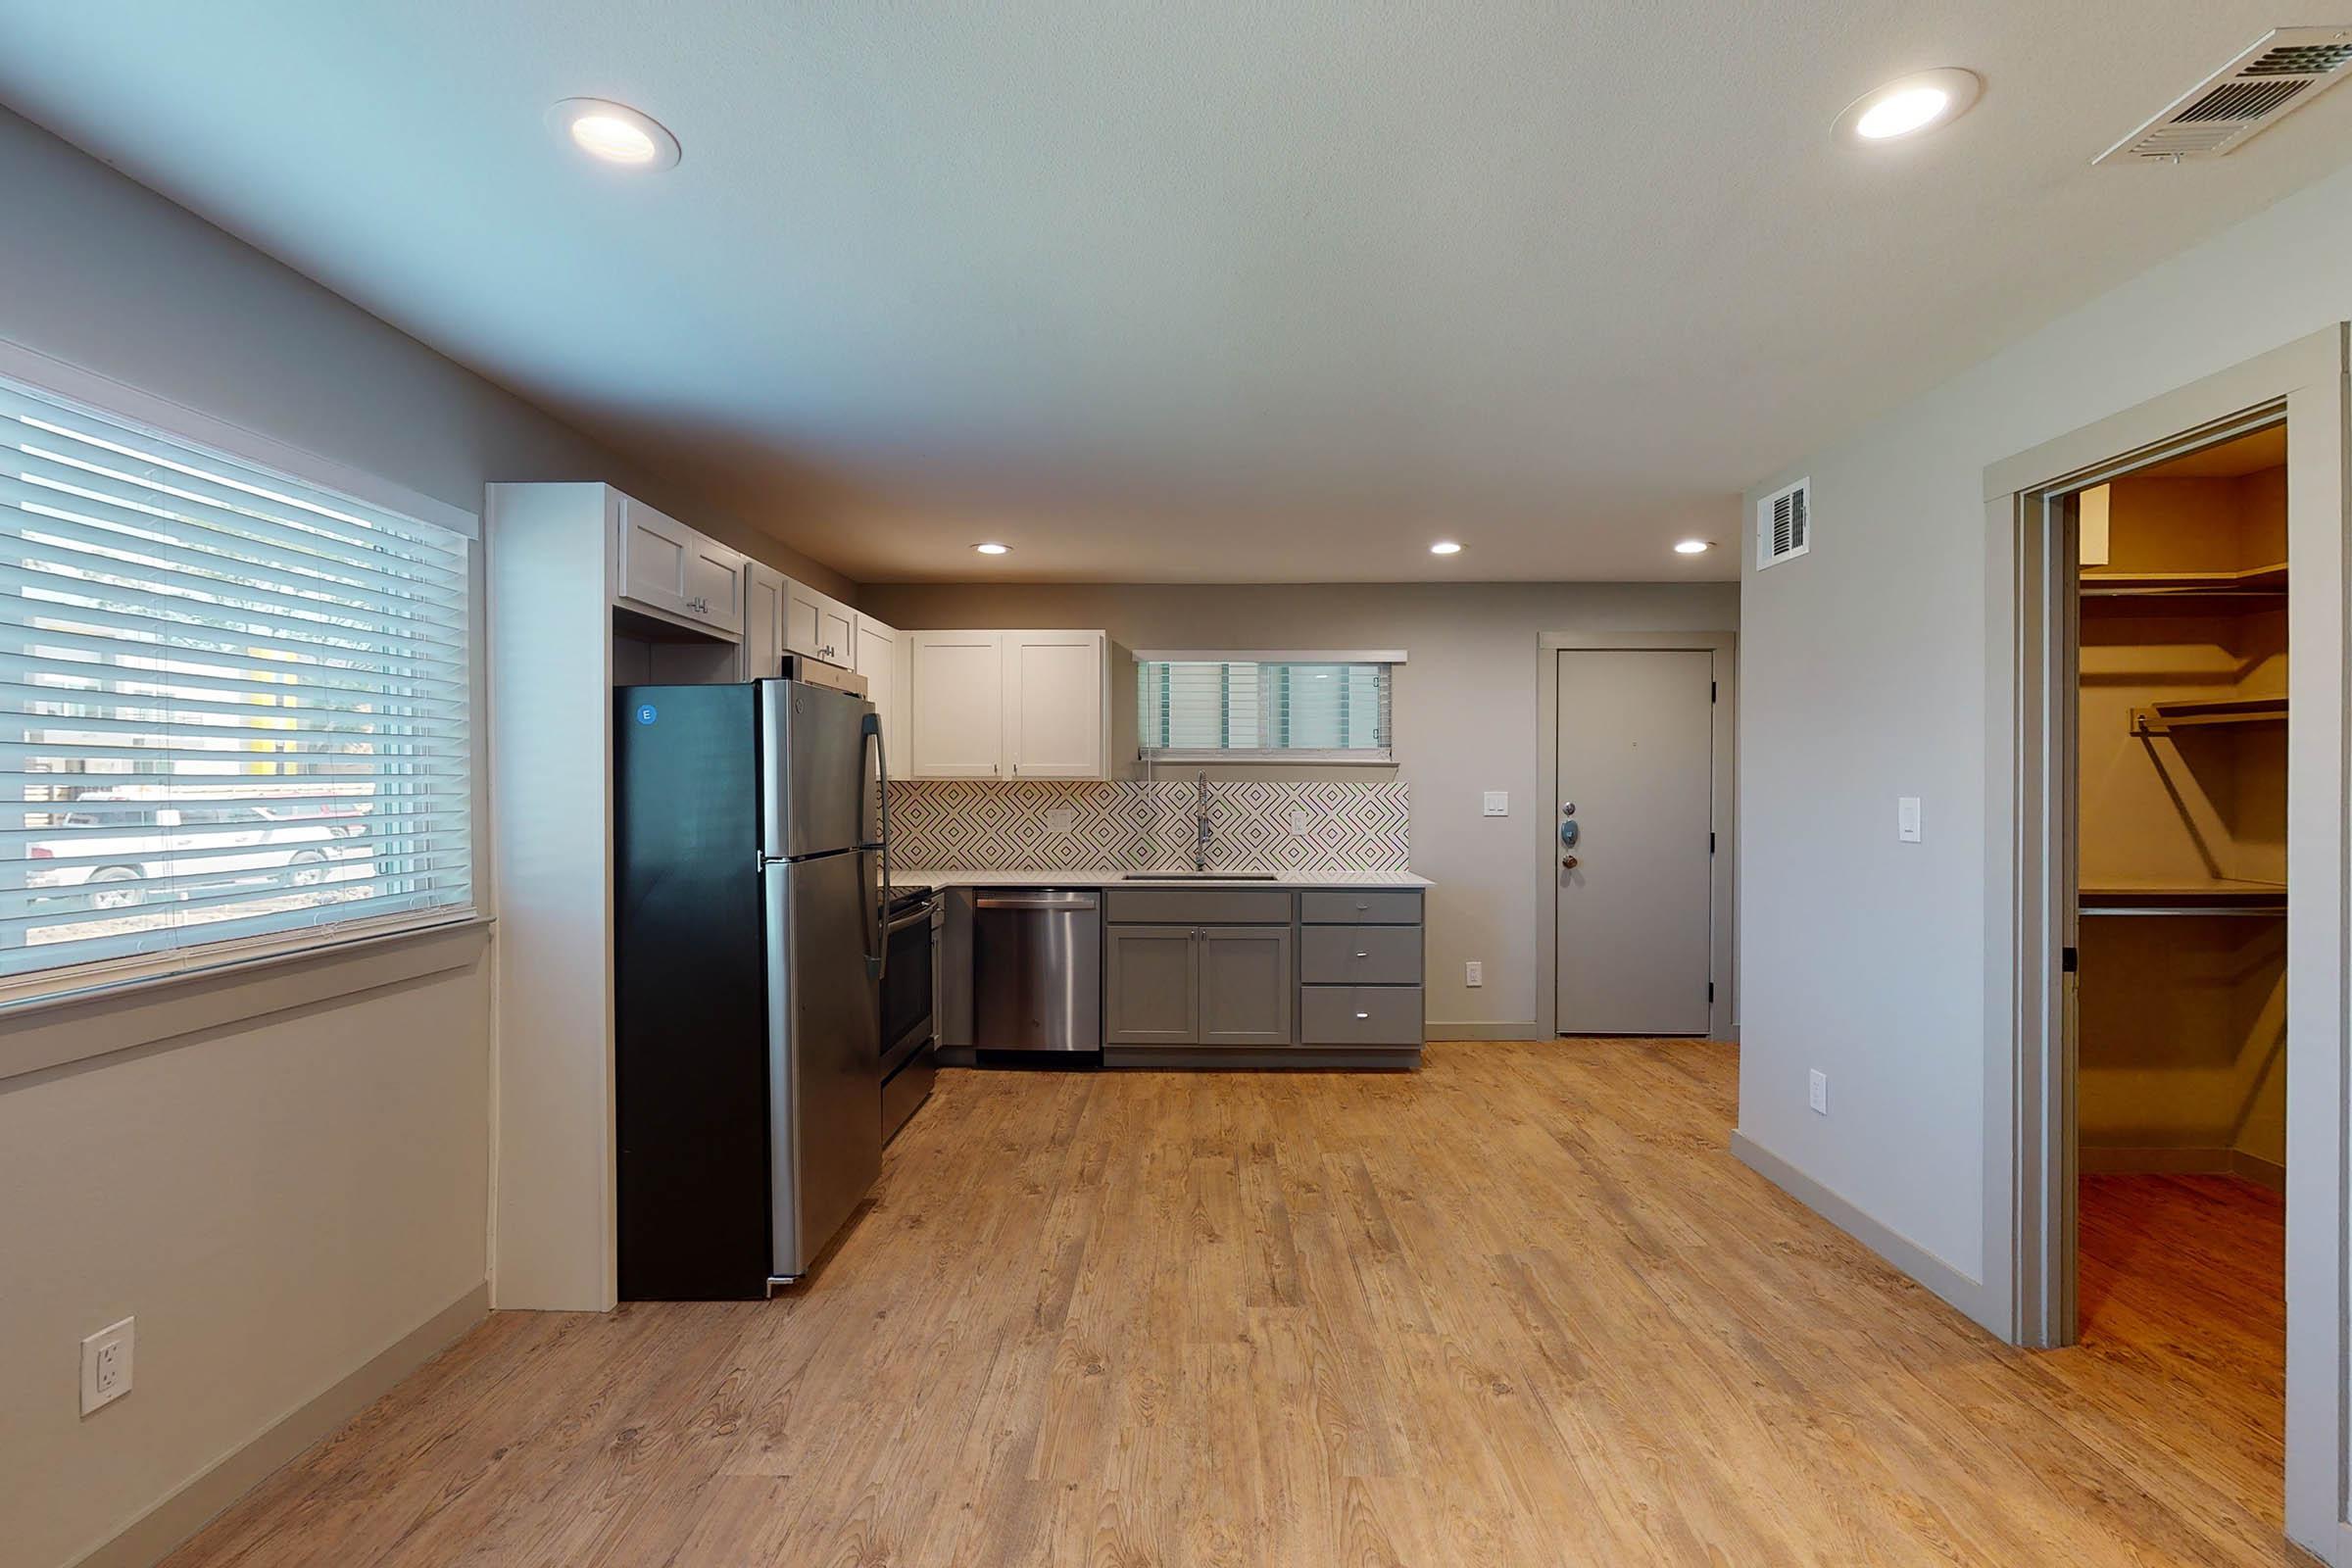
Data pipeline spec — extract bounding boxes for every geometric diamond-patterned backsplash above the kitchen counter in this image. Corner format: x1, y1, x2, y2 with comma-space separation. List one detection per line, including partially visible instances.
889, 778, 1413, 872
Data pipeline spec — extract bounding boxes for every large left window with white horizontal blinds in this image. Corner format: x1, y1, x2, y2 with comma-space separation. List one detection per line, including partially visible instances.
0, 381, 472, 997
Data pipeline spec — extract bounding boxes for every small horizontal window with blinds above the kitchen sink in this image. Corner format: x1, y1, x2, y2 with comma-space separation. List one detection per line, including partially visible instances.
1136, 654, 1395, 761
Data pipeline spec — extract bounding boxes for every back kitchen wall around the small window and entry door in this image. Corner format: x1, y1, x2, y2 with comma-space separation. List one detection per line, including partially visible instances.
858, 582, 1739, 1039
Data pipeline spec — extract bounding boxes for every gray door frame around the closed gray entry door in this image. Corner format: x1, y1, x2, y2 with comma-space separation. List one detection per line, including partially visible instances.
1534, 630, 1740, 1039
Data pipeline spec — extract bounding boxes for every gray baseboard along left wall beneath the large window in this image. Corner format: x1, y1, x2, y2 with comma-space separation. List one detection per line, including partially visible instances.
73, 1281, 489, 1568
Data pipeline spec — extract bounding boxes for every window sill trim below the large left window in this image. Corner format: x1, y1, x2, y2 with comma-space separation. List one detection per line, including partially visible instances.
0, 914, 494, 1081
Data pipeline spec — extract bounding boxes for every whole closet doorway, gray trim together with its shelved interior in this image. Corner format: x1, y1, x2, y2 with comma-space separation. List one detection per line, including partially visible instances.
1976, 324, 2352, 1563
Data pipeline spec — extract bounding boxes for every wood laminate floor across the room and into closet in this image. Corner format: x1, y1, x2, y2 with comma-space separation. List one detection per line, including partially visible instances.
172, 1042, 2298, 1568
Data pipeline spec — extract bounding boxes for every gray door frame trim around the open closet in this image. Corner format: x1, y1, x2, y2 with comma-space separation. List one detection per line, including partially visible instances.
1983, 324, 2352, 1568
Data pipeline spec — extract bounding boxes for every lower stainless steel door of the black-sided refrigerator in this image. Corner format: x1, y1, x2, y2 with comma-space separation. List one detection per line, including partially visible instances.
762, 849, 882, 1279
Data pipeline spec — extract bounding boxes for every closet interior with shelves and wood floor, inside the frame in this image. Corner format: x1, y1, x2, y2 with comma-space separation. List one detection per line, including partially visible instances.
2058, 422, 2295, 1429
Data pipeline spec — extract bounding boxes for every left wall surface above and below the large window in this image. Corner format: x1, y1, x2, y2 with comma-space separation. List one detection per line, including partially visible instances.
0, 113, 845, 1568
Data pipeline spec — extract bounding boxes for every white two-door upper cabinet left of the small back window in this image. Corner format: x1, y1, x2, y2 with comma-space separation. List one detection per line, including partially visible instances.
906, 632, 1110, 778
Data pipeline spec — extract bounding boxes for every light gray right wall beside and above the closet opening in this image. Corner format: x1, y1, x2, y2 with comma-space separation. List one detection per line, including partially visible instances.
1740, 143, 2352, 1325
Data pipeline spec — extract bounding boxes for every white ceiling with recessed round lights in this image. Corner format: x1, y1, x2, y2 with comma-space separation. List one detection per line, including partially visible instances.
0, 0, 2352, 581
